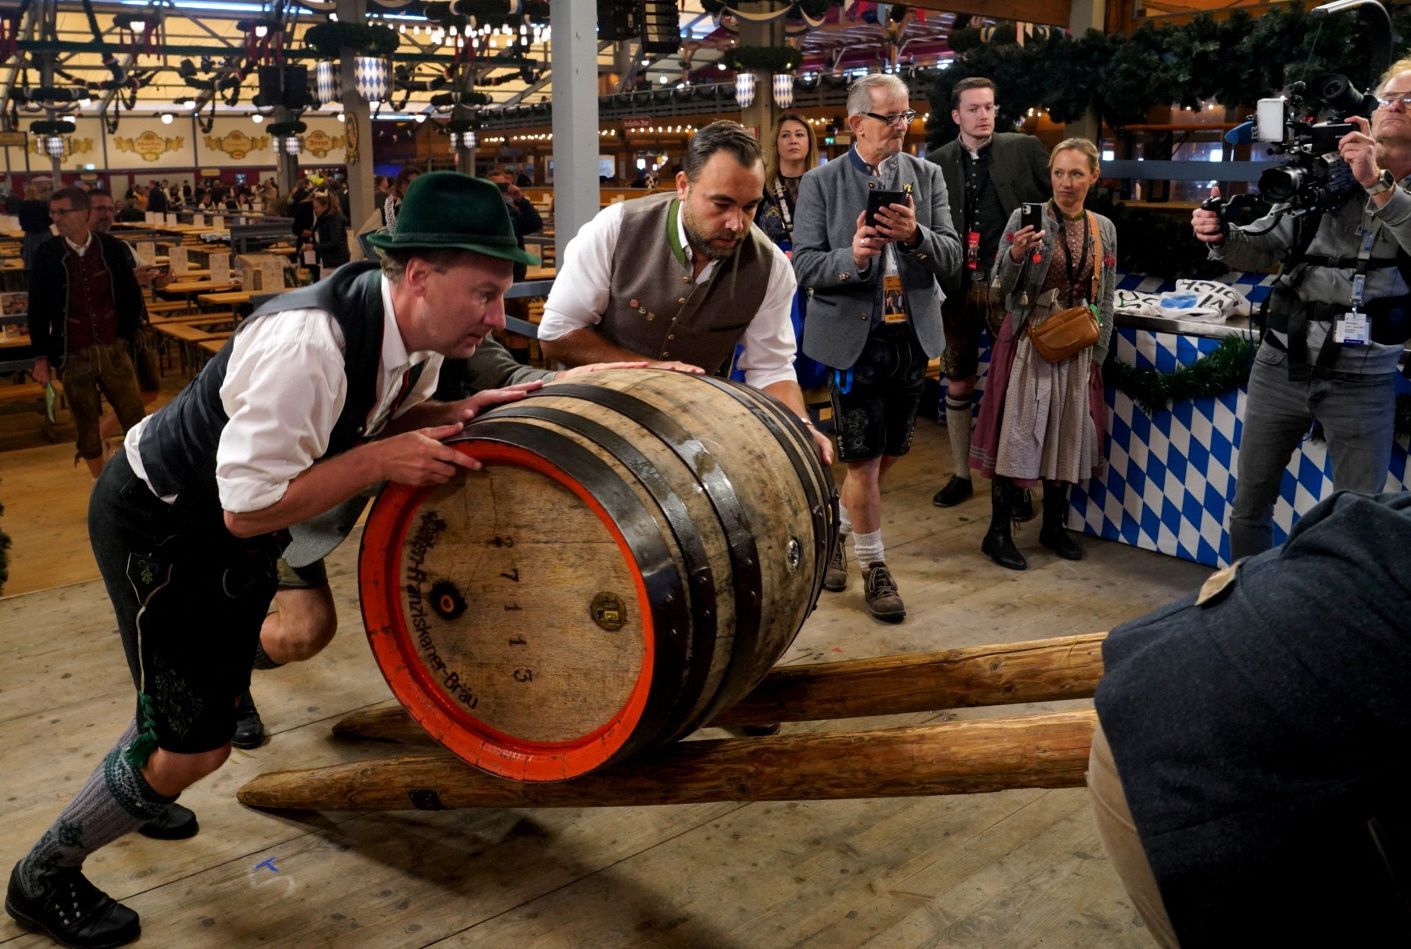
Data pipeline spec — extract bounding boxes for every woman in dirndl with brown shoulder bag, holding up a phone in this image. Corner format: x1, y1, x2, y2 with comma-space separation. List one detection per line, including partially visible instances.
971, 138, 1118, 570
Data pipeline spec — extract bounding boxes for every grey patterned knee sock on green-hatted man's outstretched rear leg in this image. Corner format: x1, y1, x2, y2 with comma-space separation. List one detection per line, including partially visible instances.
20, 725, 176, 888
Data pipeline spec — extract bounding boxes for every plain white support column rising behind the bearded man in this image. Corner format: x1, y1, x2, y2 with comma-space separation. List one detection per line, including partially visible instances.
549, 0, 598, 261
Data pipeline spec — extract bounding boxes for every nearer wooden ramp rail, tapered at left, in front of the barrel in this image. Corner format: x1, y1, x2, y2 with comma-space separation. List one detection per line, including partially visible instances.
236, 711, 1098, 811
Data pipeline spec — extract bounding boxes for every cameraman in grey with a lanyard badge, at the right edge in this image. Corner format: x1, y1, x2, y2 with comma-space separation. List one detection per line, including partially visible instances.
1191, 61, 1411, 560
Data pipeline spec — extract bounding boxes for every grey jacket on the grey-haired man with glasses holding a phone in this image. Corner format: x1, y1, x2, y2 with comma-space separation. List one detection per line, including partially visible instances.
793, 152, 961, 369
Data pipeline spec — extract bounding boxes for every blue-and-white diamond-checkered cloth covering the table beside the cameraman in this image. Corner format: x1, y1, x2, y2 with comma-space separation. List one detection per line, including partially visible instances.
1068, 326, 1407, 567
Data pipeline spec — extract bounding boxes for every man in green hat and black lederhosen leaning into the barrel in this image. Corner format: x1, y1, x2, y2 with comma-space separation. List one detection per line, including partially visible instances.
6, 172, 542, 946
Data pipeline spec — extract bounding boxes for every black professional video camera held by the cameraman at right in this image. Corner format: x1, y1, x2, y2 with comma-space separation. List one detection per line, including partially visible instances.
1254, 73, 1377, 216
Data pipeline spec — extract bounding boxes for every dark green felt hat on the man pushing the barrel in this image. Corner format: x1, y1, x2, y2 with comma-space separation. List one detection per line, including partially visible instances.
367, 172, 539, 264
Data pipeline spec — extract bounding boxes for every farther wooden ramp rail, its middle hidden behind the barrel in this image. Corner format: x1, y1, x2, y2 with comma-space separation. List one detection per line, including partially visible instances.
333, 633, 1108, 743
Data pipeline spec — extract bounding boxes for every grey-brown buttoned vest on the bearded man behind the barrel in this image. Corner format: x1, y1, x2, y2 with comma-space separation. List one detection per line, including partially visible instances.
597, 195, 773, 372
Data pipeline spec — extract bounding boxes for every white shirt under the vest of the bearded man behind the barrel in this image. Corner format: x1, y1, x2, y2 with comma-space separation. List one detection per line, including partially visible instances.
539, 202, 799, 389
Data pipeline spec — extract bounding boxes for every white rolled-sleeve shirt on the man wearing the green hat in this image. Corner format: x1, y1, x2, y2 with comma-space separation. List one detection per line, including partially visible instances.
124, 281, 442, 513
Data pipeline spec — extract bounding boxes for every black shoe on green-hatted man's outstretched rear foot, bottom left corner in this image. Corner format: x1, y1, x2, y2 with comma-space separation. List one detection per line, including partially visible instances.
4, 863, 143, 949
